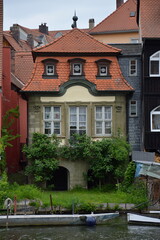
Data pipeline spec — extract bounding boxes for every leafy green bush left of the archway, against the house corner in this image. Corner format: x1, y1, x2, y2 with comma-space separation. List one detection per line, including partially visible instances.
23, 133, 59, 182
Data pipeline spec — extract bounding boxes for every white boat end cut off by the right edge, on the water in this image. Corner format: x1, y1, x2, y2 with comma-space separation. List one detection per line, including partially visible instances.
127, 213, 160, 226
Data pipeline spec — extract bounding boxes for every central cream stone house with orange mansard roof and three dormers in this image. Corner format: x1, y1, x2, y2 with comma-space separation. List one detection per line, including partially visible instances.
22, 28, 134, 190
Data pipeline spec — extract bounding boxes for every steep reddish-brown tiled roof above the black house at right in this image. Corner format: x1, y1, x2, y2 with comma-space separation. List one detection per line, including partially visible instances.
139, 0, 160, 38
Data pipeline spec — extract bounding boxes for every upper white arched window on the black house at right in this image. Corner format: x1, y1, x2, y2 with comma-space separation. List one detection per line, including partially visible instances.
150, 51, 160, 77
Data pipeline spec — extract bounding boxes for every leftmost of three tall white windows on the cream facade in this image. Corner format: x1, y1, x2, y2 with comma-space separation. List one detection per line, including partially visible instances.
43, 106, 61, 135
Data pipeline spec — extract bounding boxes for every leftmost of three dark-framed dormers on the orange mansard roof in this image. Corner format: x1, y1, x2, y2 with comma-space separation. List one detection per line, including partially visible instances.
42, 59, 58, 78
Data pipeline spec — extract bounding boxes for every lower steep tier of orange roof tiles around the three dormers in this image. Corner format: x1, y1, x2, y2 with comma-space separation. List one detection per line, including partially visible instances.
23, 56, 134, 93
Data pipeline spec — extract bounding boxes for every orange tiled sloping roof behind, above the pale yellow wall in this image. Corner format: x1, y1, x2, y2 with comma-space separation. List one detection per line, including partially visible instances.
89, 0, 138, 34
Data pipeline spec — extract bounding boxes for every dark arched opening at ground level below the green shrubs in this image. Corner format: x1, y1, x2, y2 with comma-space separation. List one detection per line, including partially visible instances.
47, 167, 69, 191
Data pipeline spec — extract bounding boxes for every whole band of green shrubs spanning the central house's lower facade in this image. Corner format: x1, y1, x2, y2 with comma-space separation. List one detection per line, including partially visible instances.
23, 133, 130, 188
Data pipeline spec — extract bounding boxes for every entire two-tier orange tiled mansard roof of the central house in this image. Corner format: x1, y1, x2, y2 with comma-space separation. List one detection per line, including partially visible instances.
23, 28, 133, 93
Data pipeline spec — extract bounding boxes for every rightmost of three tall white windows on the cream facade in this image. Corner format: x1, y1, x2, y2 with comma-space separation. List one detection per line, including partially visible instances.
95, 106, 112, 136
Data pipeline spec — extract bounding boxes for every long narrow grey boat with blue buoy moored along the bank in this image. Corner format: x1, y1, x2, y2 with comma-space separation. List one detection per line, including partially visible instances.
0, 212, 119, 227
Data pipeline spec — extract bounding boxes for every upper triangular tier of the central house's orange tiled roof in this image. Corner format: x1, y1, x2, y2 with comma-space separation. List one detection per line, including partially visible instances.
33, 28, 120, 53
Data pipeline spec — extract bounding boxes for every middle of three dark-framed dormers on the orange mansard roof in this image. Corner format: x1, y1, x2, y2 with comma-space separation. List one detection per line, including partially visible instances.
68, 58, 85, 79
